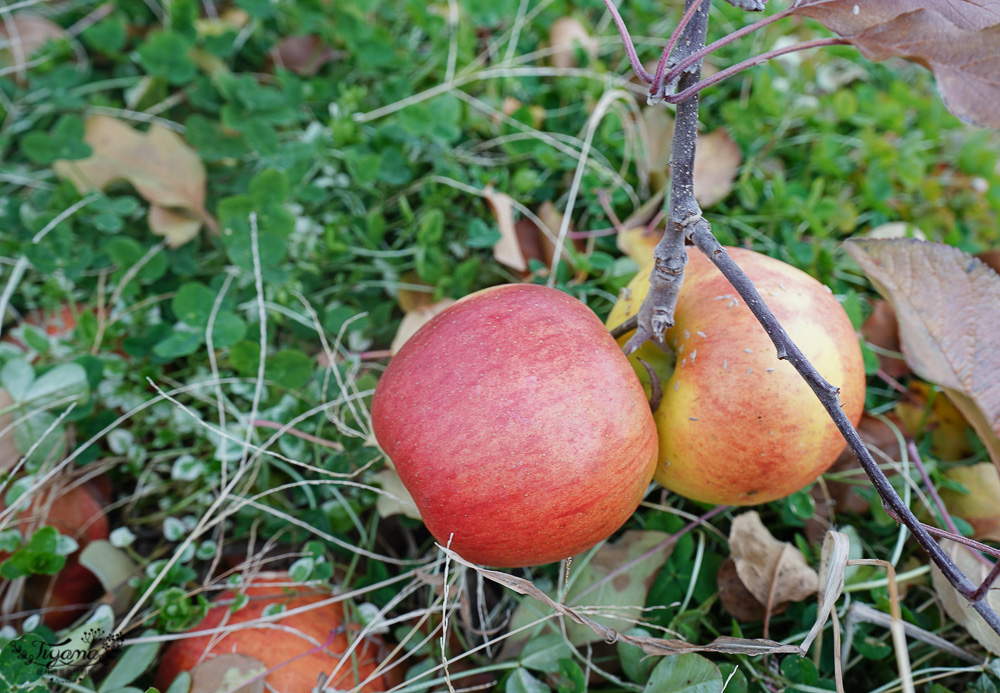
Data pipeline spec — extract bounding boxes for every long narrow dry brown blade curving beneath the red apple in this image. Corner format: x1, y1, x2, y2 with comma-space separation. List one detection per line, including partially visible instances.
438, 544, 802, 656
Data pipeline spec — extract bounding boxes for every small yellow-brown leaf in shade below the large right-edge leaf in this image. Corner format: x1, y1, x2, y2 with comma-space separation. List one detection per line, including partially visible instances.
893, 379, 973, 461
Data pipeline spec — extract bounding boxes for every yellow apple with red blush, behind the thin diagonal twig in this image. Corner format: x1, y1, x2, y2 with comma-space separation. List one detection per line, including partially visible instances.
608, 248, 865, 505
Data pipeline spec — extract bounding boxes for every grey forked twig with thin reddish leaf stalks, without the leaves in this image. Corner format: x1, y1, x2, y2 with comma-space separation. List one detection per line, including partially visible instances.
605, 0, 1000, 634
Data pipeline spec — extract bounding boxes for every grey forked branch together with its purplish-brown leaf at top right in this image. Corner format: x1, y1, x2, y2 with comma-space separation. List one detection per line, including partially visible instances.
605, 0, 1000, 633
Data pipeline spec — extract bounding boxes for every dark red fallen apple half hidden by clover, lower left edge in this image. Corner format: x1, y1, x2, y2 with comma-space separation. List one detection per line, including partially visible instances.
0, 482, 109, 630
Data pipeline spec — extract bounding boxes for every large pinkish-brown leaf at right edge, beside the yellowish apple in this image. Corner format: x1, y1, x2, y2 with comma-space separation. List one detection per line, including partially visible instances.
847, 239, 1000, 468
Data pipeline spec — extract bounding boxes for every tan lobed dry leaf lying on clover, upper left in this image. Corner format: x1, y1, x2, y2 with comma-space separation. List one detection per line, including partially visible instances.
53, 115, 217, 248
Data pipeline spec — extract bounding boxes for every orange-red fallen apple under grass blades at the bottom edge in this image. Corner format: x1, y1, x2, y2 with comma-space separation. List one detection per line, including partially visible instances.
154, 572, 397, 693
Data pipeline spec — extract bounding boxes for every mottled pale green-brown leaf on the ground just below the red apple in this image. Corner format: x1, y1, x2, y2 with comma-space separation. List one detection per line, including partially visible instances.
508, 530, 673, 649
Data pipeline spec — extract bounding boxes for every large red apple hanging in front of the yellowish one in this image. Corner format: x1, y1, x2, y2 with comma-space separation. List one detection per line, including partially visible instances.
371, 284, 657, 567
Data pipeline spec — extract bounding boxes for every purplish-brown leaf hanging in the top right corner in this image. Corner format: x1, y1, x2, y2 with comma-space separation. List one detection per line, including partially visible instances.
795, 0, 1000, 128
